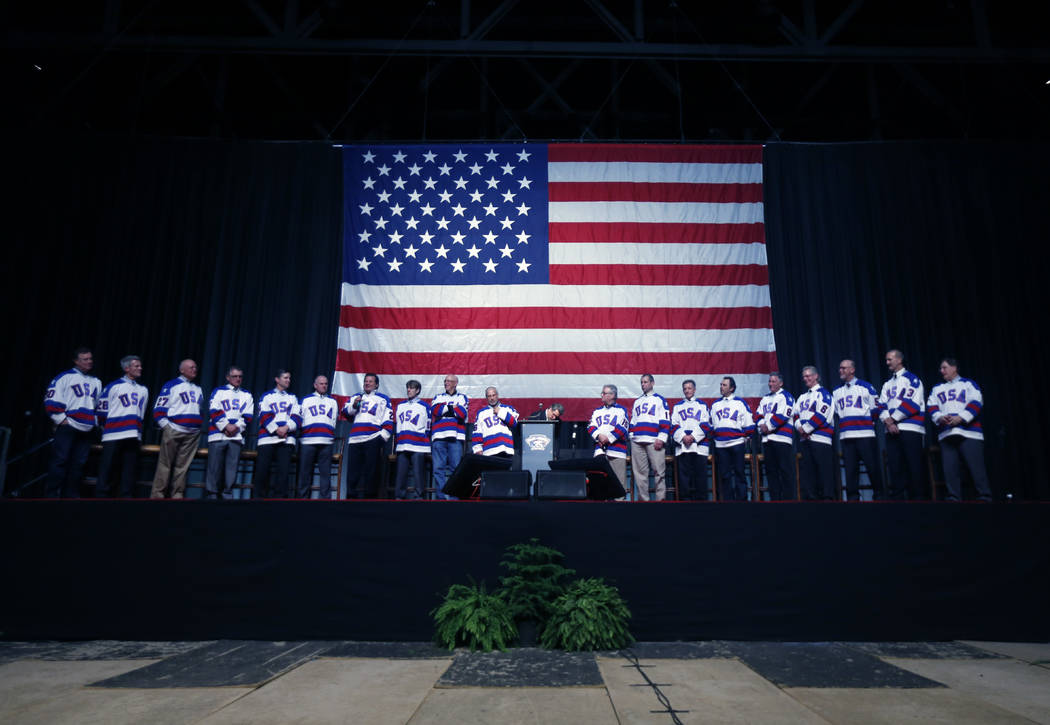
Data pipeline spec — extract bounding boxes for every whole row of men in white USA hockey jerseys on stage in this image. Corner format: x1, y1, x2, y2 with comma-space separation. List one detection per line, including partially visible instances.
45, 348, 991, 501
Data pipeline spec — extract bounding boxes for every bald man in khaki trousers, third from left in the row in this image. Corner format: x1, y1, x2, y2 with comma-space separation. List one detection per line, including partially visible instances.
150, 359, 204, 498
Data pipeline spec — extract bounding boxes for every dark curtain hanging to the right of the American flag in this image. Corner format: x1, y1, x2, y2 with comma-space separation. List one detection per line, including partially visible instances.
764, 143, 1050, 499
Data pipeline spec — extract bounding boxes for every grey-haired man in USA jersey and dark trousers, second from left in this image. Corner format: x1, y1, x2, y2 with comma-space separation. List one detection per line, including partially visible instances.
95, 355, 149, 498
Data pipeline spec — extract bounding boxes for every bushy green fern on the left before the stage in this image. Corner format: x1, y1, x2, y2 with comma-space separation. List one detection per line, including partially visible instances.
431, 580, 518, 653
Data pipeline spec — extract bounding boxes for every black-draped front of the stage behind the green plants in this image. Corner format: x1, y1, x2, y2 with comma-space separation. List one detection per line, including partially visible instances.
0, 500, 1050, 642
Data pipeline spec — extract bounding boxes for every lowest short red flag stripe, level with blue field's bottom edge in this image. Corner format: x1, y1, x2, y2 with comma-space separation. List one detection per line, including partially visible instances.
550, 265, 770, 287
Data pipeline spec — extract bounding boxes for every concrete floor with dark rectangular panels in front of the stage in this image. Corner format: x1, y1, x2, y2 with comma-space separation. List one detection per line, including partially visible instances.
0, 642, 1050, 725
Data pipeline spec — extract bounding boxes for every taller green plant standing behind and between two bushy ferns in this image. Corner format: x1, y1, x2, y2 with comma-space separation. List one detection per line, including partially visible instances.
499, 538, 575, 646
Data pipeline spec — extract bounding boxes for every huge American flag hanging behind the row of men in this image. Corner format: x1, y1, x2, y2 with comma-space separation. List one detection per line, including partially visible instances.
333, 144, 776, 420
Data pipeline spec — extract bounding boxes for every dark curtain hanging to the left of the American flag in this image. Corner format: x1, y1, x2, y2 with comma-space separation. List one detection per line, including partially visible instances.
9, 139, 342, 450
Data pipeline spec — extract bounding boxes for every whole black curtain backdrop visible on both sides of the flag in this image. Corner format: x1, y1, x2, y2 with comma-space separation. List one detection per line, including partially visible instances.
0, 138, 1050, 499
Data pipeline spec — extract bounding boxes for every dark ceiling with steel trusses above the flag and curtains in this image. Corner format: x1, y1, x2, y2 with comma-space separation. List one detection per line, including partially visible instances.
2, 0, 1050, 143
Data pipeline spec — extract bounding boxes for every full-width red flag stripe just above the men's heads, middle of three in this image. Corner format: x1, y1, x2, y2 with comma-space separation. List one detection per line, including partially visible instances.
336, 350, 777, 376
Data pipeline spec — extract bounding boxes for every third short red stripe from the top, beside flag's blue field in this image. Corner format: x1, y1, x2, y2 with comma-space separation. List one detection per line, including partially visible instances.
549, 222, 765, 244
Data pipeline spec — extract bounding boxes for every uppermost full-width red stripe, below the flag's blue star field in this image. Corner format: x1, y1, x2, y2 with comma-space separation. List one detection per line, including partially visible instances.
339, 305, 773, 330
